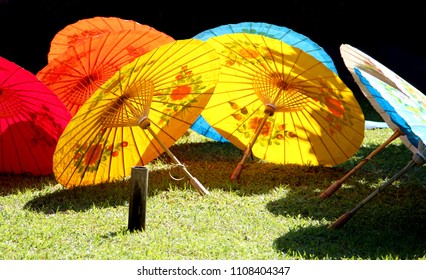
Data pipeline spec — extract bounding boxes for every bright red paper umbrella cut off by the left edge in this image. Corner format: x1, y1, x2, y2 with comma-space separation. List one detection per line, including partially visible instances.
0, 57, 71, 176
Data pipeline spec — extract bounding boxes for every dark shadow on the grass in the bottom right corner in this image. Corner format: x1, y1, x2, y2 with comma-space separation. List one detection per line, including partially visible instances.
273, 208, 426, 260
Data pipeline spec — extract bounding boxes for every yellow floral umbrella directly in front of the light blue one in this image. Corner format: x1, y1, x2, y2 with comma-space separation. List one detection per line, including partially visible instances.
202, 33, 364, 179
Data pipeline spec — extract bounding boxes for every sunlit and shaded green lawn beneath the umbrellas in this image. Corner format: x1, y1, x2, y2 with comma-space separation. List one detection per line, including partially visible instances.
0, 106, 426, 260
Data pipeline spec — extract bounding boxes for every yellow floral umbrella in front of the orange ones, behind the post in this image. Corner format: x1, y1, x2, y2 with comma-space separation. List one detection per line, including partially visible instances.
53, 39, 220, 192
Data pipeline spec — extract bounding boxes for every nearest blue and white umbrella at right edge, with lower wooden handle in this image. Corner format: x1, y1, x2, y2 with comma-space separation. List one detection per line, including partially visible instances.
330, 47, 426, 228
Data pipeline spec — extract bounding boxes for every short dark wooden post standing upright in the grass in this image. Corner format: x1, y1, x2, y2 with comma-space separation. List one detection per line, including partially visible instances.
128, 166, 148, 231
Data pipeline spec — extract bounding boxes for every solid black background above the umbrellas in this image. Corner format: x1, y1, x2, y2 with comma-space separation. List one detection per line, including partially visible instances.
0, 0, 426, 92
